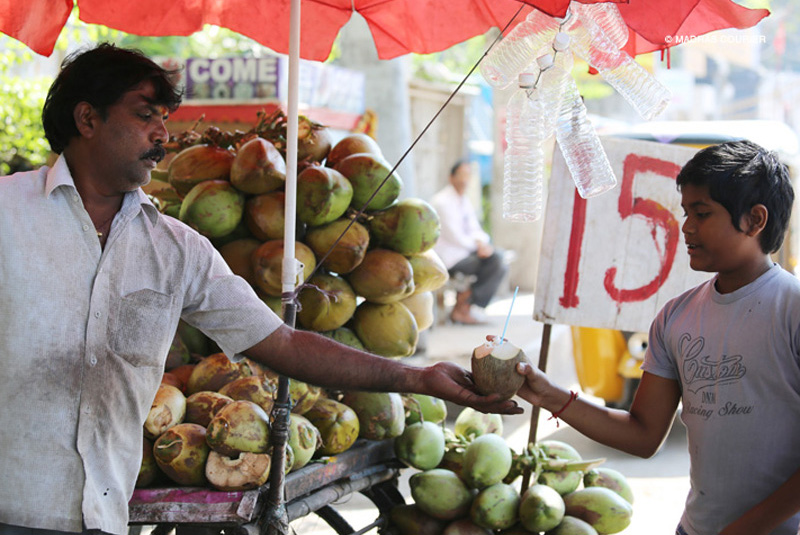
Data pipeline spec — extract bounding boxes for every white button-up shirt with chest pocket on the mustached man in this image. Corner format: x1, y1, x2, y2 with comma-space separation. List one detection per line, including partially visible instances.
0, 157, 281, 535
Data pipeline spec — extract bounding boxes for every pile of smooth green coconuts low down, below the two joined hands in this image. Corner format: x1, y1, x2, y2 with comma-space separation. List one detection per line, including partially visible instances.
387, 409, 633, 535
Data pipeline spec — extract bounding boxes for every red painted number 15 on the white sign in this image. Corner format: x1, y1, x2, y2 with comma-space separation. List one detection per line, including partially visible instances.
559, 154, 680, 308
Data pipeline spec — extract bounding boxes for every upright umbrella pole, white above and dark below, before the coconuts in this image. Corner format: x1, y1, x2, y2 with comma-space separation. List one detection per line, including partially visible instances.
259, 0, 302, 535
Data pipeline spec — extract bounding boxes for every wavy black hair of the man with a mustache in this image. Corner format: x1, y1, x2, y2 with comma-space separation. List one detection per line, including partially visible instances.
42, 43, 183, 154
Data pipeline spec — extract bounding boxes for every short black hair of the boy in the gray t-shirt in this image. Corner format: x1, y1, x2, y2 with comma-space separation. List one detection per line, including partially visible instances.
677, 140, 794, 253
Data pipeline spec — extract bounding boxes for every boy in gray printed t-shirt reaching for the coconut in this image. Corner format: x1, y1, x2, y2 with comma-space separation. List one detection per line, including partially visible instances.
519, 141, 800, 535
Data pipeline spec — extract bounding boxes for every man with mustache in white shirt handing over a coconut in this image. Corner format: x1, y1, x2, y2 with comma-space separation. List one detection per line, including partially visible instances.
0, 43, 522, 535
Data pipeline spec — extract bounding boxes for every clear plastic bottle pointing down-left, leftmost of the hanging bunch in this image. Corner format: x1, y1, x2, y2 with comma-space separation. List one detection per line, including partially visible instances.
480, 9, 560, 88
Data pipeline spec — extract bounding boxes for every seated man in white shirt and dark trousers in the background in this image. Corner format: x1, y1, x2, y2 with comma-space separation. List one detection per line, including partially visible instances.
431, 160, 507, 324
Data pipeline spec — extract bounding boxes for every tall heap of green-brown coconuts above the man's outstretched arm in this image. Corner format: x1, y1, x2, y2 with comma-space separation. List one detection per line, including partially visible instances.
151, 111, 448, 358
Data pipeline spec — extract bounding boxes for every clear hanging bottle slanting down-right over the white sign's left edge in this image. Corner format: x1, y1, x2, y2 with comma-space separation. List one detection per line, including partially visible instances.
539, 33, 617, 199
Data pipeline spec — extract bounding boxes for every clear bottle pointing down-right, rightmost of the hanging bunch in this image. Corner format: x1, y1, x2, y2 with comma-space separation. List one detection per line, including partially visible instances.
564, 10, 672, 120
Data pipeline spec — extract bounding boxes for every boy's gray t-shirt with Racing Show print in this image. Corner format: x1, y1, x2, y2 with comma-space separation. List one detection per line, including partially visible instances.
643, 264, 800, 535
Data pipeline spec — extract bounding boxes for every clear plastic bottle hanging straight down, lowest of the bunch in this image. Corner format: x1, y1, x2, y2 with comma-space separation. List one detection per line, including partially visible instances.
503, 73, 545, 222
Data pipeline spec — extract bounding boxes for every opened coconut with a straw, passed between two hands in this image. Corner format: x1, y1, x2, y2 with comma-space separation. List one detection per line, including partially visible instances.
472, 288, 528, 399
